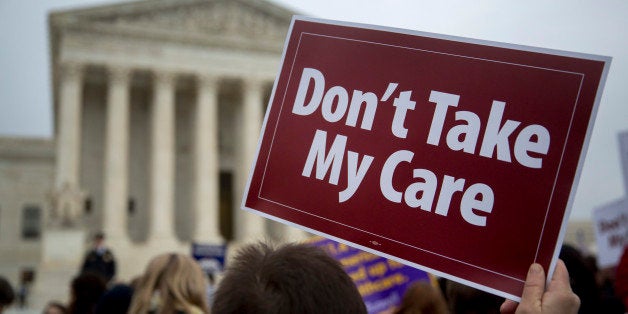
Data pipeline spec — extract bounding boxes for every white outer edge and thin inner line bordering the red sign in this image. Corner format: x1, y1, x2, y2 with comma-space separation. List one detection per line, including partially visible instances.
241, 16, 611, 301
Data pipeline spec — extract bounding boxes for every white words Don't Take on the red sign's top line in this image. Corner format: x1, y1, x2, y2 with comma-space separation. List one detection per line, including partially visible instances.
292, 68, 550, 169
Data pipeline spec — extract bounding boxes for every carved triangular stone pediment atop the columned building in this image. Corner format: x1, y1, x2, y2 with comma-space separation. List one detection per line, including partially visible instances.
51, 0, 294, 51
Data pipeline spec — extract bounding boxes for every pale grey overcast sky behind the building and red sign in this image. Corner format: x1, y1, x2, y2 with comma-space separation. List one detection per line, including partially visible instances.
0, 0, 628, 219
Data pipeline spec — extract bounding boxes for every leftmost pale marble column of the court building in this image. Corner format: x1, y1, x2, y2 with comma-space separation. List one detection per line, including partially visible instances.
54, 62, 84, 225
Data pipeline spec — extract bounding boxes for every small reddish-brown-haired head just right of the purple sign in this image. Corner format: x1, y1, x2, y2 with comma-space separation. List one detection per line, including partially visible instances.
394, 282, 449, 314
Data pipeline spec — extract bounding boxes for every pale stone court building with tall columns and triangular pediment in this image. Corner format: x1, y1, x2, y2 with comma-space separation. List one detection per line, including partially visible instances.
0, 0, 305, 306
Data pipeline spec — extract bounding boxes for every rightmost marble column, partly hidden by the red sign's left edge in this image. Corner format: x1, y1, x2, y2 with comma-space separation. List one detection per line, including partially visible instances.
234, 79, 266, 241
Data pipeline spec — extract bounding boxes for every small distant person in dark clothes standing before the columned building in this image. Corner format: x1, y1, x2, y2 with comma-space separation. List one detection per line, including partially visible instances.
81, 232, 116, 283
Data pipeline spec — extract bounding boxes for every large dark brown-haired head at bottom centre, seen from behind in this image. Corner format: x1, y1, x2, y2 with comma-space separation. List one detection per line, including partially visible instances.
211, 243, 366, 314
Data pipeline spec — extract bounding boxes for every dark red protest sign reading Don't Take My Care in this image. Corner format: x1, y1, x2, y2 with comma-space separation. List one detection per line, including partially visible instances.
243, 18, 610, 300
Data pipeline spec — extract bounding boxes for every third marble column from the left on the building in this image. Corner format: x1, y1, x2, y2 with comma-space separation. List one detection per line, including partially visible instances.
148, 72, 176, 244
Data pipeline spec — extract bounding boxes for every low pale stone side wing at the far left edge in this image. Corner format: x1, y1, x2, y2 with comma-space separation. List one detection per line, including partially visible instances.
0, 138, 54, 283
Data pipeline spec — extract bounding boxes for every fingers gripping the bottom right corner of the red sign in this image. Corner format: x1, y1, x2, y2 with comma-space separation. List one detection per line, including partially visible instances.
500, 260, 580, 314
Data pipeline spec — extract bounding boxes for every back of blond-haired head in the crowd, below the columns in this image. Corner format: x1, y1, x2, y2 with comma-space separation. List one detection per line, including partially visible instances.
129, 253, 209, 314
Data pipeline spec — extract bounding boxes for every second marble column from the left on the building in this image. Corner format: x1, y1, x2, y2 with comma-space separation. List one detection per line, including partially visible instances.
103, 67, 131, 240
